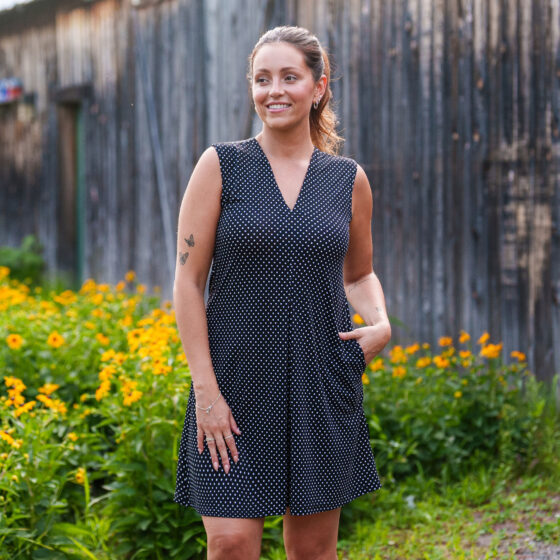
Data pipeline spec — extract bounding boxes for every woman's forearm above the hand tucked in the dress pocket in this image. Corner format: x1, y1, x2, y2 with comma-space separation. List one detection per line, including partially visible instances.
344, 271, 391, 337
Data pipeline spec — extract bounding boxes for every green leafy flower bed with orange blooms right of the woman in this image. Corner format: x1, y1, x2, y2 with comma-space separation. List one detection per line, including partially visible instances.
364, 344, 560, 484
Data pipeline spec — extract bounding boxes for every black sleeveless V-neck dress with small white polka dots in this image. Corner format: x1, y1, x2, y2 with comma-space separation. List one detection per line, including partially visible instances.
173, 137, 381, 517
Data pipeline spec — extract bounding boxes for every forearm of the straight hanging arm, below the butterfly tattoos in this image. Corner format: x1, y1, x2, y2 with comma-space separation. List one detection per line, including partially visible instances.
173, 282, 219, 400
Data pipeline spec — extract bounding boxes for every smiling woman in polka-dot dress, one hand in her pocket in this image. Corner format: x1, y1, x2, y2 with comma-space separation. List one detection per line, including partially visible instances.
174, 26, 391, 560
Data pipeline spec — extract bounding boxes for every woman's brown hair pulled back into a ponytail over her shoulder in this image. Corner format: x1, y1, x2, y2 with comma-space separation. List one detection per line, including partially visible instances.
247, 25, 344, 154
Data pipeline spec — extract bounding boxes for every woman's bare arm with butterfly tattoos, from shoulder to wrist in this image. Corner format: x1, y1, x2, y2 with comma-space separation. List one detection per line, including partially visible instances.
173, 146, 222, 400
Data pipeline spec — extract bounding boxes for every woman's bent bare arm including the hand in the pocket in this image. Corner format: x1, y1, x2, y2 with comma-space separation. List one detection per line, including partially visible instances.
339, 165, 391, 362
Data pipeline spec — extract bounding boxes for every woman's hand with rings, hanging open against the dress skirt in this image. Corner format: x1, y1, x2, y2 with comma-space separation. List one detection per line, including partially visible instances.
196, 395, 241, 474
